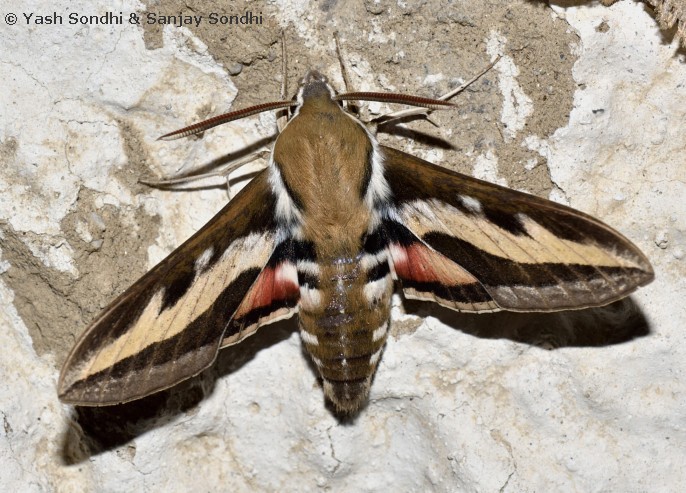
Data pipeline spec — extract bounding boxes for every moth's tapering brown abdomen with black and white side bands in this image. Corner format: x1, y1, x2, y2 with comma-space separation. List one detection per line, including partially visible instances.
298, 252, 393, 412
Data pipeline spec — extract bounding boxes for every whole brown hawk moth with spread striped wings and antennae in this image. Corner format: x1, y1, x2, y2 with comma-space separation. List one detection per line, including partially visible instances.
58, 66, 653, 413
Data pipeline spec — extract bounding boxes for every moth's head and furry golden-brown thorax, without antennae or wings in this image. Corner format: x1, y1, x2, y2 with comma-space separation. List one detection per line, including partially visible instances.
274, 74, 374, 258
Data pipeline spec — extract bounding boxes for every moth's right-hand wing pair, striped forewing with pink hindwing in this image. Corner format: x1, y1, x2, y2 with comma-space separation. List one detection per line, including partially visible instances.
382, 147, 654, 312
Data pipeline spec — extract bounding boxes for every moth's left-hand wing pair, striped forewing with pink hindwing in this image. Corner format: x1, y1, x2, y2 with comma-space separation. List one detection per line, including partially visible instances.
59, 172, 297, 405
